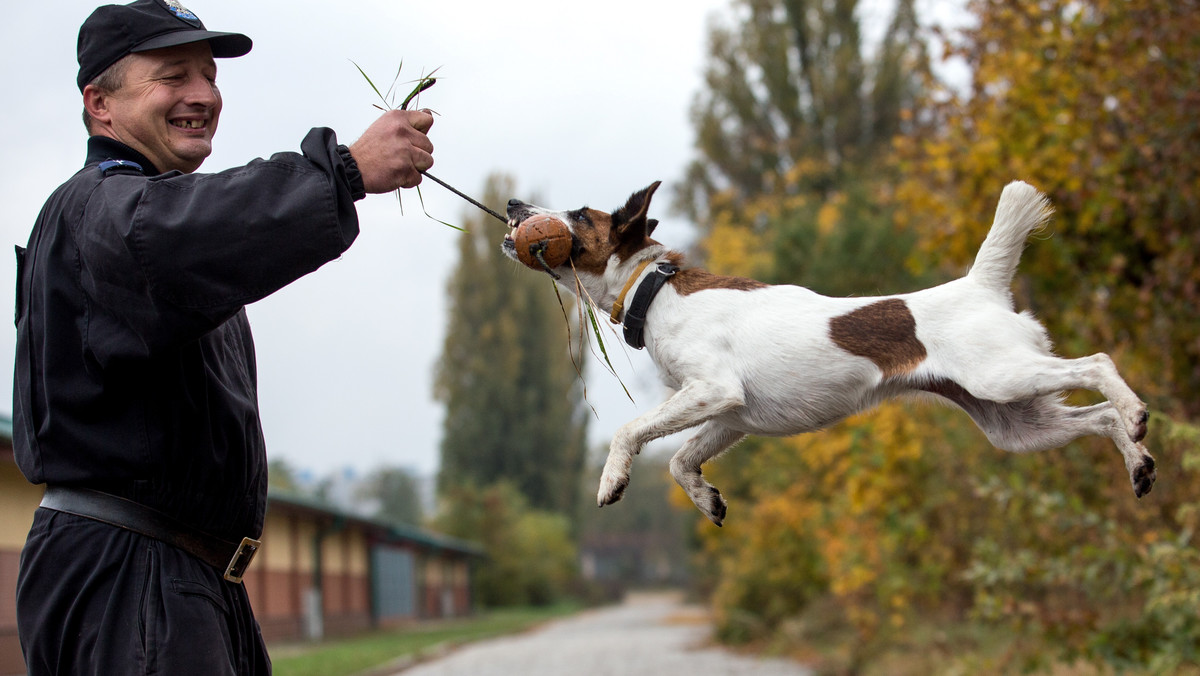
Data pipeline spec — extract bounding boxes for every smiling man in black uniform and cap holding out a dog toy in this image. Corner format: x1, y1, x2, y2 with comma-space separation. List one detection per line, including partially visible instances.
13, 0, 433, 676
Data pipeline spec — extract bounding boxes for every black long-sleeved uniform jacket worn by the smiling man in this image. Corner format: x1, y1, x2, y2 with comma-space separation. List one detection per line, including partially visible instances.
13, 128, 364, 542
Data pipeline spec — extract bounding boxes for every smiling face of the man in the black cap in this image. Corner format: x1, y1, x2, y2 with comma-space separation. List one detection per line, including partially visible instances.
101, 42, 221, 173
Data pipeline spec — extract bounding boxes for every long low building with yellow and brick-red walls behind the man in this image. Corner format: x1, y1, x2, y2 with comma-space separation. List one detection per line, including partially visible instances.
0, 417, 482, 675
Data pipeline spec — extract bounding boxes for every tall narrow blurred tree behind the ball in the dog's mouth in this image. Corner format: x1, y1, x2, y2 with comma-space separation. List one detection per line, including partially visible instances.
434, 177, 587, 512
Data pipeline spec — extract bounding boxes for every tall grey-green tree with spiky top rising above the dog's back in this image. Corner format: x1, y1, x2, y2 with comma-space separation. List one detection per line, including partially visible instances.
677, 0, 928, 294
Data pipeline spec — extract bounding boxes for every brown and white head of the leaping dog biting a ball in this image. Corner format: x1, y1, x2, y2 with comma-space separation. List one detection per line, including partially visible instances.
503, 181, 661, 277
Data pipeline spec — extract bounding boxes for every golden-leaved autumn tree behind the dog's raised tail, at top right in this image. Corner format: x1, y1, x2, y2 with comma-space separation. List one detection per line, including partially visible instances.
900, 0, 1200, 419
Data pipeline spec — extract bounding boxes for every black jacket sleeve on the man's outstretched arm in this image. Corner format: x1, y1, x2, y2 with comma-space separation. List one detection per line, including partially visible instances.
76, 128, 362, 361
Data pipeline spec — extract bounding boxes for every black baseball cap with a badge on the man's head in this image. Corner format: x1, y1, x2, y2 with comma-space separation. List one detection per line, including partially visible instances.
76, 0, 254, 91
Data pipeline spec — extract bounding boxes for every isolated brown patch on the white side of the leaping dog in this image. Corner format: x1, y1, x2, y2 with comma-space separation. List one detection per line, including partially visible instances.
829, 298, 926, 377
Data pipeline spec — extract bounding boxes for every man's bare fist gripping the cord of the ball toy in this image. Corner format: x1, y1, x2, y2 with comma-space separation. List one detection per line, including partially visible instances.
350, 110, 433, 192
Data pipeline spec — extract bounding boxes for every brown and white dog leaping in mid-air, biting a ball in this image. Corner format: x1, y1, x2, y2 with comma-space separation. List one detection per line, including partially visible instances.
504, 183, 1156, 526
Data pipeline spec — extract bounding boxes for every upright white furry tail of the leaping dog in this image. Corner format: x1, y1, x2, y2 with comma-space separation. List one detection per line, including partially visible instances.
967, 181, 1054, 295
